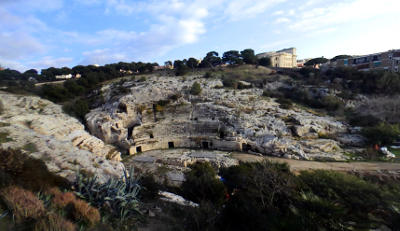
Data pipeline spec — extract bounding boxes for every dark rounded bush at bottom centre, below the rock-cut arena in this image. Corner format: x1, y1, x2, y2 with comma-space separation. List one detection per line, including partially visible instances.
182, 162, 225, 205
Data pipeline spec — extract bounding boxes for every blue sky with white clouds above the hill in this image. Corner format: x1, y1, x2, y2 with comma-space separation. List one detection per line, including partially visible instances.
0, 0, 400, 71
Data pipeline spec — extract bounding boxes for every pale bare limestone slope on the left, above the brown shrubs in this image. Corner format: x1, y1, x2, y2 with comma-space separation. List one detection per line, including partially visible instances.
0, 92, 124, 181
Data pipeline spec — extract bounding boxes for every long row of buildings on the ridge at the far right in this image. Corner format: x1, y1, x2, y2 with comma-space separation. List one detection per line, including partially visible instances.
324, 49, 400, 72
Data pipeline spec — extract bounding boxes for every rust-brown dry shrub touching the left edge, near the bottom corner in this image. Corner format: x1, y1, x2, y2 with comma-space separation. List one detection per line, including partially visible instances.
0, 186, 46, 223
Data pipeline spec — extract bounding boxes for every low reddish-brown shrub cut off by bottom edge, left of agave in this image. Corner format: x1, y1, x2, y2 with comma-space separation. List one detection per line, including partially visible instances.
34, 214, 76, 231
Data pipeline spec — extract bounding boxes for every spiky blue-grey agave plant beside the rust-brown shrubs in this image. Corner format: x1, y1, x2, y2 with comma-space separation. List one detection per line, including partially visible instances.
74, 168, 140, 220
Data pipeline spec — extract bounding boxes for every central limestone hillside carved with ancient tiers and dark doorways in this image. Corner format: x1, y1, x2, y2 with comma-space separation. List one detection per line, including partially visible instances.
86, 76, 360, 160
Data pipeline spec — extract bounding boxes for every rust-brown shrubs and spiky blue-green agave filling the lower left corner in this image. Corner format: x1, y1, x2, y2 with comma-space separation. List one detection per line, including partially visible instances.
0, 149, 145, 231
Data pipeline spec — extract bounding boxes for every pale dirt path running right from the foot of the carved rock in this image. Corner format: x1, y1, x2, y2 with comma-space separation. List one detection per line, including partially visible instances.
232, 153, 400, 174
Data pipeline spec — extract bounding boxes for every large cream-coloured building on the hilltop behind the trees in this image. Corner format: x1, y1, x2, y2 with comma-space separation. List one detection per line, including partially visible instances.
257, 47, 297, 68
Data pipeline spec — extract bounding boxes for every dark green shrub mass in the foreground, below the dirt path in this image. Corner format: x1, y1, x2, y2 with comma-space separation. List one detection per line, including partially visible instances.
174, 162, 400, 230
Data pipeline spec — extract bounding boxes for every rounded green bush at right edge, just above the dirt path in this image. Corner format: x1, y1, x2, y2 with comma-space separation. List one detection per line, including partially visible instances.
362, 122, 400, 145
